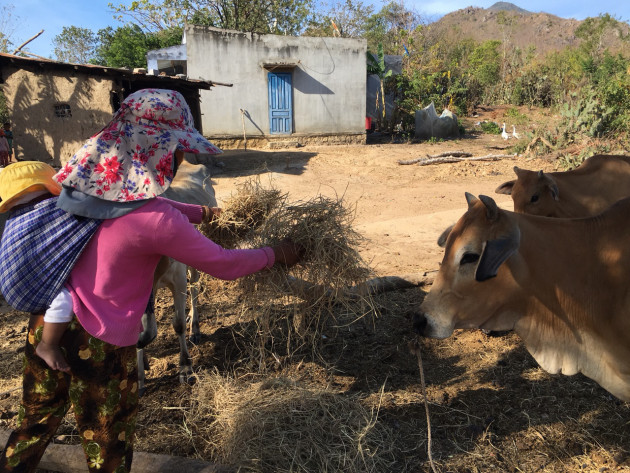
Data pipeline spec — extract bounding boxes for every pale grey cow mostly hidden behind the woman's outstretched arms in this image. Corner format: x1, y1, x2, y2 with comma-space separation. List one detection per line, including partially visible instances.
138, 161, 216, 392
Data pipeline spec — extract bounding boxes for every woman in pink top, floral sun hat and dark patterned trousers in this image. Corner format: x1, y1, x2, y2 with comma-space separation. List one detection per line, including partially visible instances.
0, 89, 300, 473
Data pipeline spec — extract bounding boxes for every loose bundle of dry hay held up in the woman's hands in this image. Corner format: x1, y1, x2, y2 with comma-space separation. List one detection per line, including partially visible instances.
200, 181, 375, 371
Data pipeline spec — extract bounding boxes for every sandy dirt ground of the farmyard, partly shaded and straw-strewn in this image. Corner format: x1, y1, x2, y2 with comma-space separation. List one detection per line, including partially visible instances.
0, 108, 630, 473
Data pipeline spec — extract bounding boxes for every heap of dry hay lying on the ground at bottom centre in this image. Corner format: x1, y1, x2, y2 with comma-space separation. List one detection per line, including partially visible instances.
186, 373, 396, 473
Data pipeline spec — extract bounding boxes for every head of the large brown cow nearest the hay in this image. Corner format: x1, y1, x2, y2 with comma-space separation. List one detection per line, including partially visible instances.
414, 193, 520, 338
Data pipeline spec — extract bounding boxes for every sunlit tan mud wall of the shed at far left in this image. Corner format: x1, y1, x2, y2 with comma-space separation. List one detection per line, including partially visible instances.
2, 66, 115, 166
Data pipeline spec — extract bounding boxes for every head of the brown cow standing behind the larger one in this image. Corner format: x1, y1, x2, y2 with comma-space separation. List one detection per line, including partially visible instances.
495, 166, 560, 217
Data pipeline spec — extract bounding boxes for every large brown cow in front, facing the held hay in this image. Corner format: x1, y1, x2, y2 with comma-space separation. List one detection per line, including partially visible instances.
414, 194, 630, 401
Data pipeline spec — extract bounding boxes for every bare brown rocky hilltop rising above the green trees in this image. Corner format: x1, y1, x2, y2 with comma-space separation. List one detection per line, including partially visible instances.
429, 2, 630, 54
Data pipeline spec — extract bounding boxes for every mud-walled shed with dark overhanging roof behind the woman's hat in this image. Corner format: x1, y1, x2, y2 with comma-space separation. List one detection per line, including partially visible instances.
0, 54, 214, 166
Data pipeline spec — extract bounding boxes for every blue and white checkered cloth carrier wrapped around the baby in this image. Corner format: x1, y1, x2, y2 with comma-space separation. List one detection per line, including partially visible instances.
0, 197, 101, 312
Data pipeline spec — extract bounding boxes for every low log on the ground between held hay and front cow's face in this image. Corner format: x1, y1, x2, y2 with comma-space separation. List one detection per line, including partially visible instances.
286, 270, 437, 300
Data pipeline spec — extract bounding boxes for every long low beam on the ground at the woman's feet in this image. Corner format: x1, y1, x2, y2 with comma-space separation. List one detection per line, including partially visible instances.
0, 429, 236, 473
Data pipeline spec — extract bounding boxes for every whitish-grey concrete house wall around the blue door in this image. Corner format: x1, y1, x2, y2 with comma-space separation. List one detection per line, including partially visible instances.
186, 25, 367, 145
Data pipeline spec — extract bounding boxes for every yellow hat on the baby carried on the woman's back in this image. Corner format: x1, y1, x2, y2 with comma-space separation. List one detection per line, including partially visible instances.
0, 161, 61, 213
